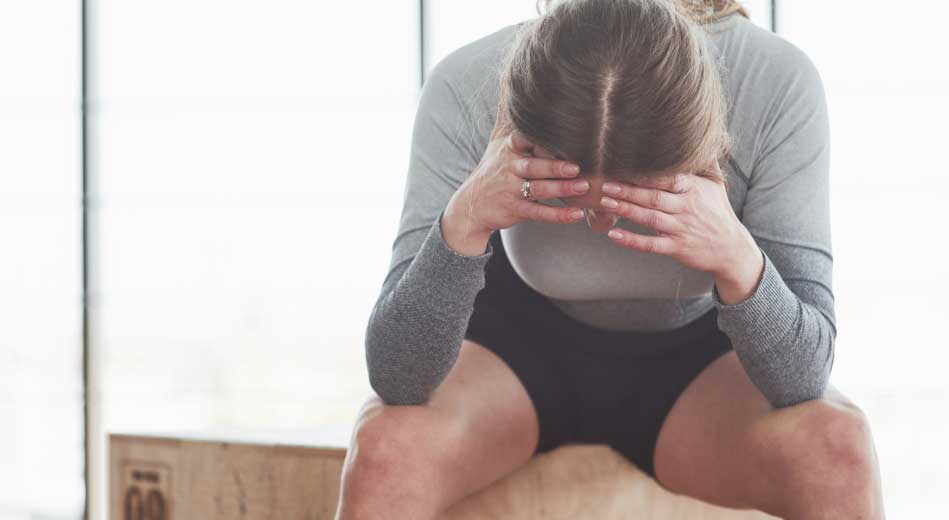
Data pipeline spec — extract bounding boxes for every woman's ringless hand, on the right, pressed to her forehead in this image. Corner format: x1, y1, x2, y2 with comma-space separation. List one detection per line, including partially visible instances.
601, 163, 764, 304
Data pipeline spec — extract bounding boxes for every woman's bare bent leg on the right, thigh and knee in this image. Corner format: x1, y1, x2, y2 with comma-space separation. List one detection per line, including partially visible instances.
655, 352, 884, 520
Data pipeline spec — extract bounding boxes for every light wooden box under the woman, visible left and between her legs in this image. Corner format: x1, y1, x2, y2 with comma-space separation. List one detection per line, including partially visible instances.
109, 435, 771, 520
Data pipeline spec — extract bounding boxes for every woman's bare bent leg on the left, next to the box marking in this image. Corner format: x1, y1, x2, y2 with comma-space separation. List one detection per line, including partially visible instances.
336, 340, 539, 520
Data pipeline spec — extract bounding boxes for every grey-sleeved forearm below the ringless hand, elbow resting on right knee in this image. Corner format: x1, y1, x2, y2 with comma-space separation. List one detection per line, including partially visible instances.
715, 246, 836, 407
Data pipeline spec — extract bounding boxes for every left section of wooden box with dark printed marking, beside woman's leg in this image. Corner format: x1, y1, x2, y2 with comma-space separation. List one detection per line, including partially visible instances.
109, 435, 346, 520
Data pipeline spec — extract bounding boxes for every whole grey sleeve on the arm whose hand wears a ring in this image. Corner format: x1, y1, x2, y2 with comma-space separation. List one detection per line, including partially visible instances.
365, 58, 494, 405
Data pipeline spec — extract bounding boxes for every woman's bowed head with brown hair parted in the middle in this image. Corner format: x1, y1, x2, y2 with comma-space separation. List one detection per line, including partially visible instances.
501, 0, 729, 191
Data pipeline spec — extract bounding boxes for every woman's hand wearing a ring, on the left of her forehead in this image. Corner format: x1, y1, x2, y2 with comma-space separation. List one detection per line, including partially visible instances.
443, 107, 590, 250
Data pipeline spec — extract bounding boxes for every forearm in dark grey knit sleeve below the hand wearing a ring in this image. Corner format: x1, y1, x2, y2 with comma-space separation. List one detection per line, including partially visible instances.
366, 210, 493, 405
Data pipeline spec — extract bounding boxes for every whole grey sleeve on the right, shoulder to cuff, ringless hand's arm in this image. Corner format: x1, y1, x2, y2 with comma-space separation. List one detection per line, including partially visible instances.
714, 45, 837, 407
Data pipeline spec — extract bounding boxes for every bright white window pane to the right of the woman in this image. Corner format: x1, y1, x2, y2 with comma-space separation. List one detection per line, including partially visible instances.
778, 0, 949, 518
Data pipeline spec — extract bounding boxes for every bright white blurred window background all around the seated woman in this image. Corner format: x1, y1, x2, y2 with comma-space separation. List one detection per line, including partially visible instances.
0, 0, 949, 520
